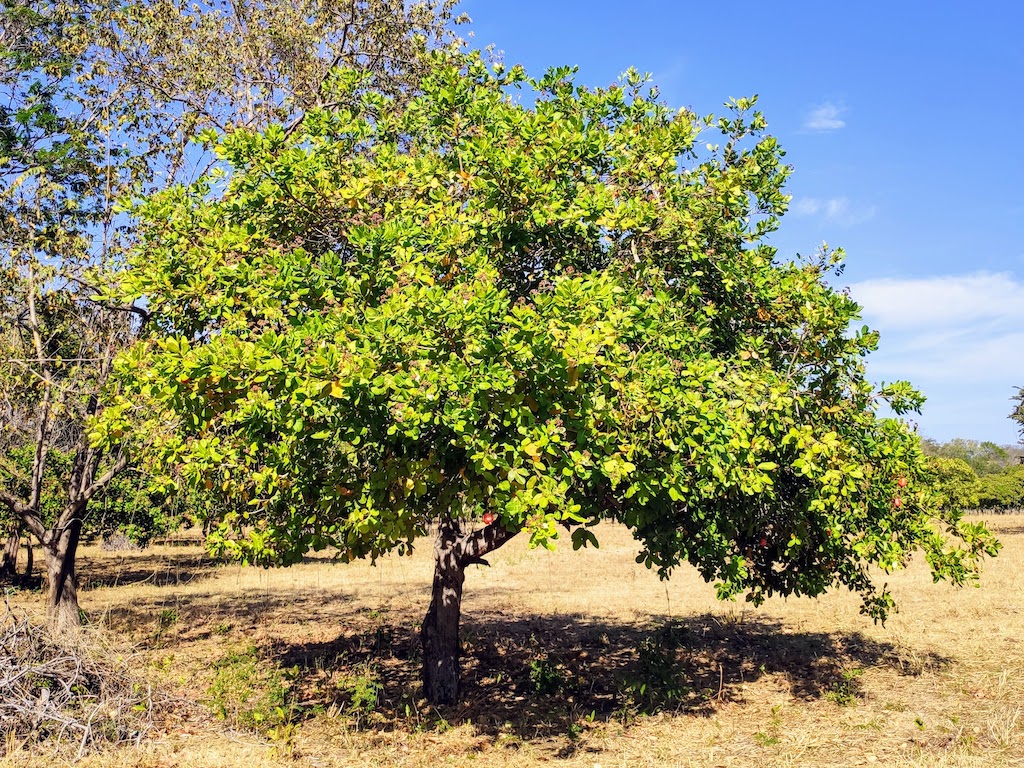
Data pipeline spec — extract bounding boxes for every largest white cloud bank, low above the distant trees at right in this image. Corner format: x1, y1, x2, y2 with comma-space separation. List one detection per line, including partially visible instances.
850, 272, 1024, 442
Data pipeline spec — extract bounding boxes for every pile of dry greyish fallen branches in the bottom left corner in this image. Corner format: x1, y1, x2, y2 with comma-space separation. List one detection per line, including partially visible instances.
0, 603, 153, 758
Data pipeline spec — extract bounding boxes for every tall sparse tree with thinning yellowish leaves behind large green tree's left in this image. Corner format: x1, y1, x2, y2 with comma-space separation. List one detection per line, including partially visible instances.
0, 0, 454, 625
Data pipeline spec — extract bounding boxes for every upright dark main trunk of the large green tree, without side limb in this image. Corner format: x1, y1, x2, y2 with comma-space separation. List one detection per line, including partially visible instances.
420, 520, 466, 705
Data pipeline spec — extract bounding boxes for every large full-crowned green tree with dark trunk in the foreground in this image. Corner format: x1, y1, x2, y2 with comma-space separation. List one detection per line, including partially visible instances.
103, 57, 996, 702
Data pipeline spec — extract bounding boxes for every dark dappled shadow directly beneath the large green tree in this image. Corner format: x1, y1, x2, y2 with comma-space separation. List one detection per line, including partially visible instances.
263, 612, 949, 750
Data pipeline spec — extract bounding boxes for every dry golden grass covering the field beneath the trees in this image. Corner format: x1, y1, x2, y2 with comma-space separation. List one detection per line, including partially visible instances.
2, 516, 1024, 768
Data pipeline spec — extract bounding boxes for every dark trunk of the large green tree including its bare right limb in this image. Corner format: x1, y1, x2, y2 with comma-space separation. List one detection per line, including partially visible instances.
420, 519, 518, 705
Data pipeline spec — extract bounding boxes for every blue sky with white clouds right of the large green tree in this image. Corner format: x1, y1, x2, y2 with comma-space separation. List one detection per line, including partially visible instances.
460, 0, 1024, 443
